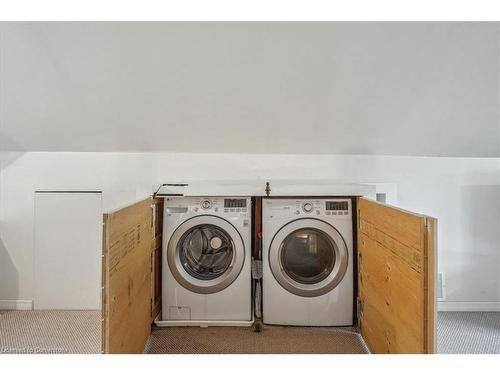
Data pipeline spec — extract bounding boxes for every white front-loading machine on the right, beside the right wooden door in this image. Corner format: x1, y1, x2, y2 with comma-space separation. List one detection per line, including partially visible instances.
262, 198, 354, 326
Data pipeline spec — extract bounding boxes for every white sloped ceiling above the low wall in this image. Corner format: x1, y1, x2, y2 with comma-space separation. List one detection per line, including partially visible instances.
0, 22, 500, 157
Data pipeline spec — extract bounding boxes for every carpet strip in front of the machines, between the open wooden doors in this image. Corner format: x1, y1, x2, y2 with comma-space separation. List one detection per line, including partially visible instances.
147, 326, 368, 354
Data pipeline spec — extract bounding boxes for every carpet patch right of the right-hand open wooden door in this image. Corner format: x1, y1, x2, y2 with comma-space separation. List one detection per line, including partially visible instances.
437, 311, 500, 354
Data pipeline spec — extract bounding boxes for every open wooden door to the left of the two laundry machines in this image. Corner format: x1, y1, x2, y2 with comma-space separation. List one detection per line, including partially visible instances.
102, 198, 153, 353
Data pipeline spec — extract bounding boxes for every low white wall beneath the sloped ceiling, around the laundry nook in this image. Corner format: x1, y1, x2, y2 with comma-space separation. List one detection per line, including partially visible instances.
0, 153, 500, 306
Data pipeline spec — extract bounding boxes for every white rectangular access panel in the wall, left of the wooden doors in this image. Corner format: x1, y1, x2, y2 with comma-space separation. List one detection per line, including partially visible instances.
33, 192, 102, 310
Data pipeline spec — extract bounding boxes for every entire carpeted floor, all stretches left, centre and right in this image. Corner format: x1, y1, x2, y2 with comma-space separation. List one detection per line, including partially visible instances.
0, 311, 500, 354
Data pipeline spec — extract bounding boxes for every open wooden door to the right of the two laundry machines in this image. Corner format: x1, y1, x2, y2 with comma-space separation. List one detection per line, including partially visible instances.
357, 198, 436, 353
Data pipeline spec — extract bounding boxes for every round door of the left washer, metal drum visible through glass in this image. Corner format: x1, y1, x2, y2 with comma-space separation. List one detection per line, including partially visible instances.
167, 215, 245, 294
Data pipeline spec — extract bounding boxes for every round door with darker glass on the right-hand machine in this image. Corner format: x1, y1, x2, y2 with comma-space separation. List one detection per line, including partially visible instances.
268, 218, 349, 297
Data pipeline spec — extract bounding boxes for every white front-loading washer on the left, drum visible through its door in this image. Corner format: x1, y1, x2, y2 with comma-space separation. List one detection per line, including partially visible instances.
157, 197, 253, 326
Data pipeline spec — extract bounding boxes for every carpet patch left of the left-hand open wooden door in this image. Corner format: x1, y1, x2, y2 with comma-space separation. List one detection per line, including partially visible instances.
0, 310, 101, 354
